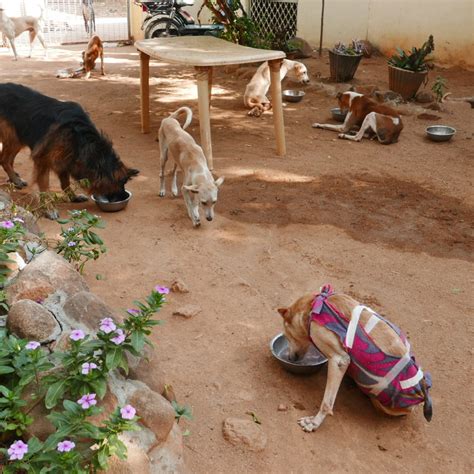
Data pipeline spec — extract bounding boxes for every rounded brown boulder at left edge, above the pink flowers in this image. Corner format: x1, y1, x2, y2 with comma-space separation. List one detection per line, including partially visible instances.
7, 300, 61, 342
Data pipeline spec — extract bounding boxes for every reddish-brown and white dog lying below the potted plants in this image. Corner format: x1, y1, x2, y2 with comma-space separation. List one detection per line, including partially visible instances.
313, 91, 403, 145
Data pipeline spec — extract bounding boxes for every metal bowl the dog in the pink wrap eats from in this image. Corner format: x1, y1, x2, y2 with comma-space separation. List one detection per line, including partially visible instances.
270, 333, 328, 374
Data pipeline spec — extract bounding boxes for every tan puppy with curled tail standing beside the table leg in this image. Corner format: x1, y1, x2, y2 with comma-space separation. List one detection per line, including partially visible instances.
158, 107, 224, 227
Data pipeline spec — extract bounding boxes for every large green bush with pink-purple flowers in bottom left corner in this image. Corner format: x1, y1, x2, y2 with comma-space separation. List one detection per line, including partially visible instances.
0, 286, 168, 473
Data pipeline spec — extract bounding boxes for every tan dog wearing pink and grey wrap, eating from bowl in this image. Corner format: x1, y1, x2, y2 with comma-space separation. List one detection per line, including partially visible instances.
278, 285, 433, 431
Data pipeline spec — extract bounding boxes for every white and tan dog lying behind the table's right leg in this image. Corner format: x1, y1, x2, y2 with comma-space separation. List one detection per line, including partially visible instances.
244, 59, 309, 117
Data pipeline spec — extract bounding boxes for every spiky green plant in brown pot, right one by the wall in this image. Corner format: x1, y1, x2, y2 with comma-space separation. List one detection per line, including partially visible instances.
388, 35, 434, 100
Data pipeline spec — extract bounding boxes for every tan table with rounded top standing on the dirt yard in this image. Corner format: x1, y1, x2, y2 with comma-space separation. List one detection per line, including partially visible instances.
135, 36, 286, 170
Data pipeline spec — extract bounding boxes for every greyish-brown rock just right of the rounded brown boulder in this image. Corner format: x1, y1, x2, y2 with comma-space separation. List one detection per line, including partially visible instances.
63, 291, 114, 331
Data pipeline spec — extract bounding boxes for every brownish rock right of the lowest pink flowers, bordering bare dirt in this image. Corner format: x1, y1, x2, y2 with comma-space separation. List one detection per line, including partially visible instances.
128, 380, 175, 443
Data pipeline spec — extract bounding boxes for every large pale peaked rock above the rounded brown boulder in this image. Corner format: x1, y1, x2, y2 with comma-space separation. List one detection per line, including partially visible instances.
7, 250, 88, 304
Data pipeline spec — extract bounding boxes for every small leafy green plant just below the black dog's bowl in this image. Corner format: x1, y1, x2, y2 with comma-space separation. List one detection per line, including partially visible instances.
56, 209, 107, 273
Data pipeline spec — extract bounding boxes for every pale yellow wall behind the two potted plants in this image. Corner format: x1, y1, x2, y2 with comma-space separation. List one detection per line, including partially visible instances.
298, 0, 474, 68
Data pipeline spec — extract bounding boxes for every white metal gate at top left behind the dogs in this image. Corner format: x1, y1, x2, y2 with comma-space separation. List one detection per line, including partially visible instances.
2, 0, 129, 45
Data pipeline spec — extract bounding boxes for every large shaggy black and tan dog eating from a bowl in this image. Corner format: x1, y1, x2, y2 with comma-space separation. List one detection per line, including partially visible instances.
0, 83, 139, 219
